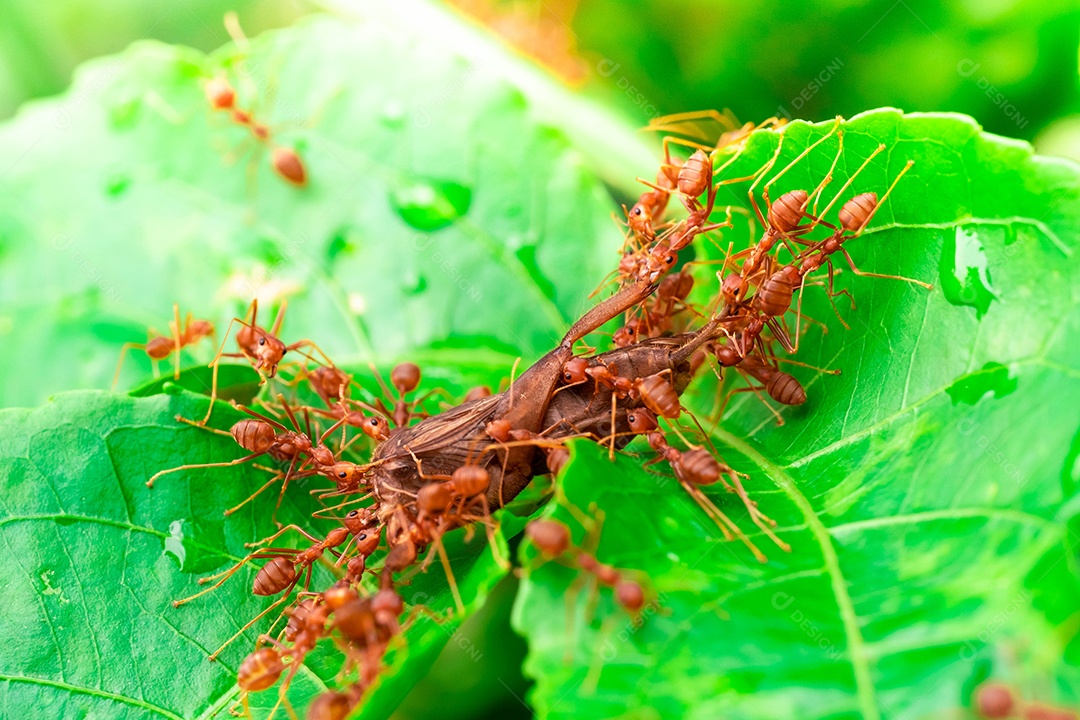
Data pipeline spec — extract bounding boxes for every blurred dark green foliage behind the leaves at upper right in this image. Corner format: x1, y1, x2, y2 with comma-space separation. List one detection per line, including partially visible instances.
565, 0, 1080, 138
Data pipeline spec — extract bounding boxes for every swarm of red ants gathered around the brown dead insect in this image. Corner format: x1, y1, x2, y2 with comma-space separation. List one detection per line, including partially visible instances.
118, 106, 950, 720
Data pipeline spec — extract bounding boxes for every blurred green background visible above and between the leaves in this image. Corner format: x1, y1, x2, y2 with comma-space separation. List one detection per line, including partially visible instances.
0, 0, 1080, 720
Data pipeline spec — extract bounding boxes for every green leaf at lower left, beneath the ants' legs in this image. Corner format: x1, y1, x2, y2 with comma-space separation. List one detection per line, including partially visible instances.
0, 392, 509, 718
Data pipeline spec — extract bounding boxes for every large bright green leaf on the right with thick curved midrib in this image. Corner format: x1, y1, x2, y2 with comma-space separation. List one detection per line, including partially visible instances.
515, 110, 1080, 719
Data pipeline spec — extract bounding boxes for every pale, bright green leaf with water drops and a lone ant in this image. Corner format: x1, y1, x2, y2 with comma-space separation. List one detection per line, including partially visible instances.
0, 2, 643, 405
